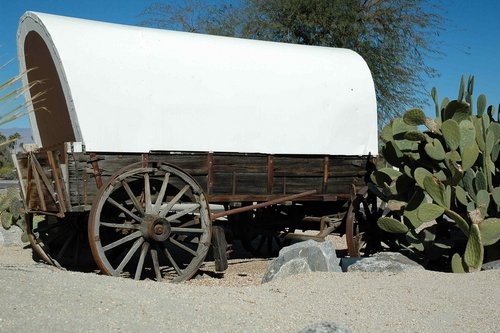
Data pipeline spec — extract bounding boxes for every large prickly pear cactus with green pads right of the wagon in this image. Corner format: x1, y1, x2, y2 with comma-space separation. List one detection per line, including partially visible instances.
371, 77, 500, 272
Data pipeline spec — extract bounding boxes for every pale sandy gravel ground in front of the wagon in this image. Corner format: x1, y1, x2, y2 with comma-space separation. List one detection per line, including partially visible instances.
0, 247, 500, 332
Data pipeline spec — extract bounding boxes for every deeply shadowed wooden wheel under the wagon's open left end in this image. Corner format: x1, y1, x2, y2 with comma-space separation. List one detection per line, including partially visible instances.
25, 213, 95, 270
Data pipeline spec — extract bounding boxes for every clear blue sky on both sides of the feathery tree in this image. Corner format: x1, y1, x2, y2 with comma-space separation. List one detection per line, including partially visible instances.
0, 0, 500, 129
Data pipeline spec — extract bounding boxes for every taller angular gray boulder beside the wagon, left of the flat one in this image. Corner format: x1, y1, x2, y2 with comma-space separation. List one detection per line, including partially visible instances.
262, 240, 341, 283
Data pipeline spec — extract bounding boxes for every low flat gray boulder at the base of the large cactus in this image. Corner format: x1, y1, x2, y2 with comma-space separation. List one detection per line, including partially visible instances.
347, 252, 424, 273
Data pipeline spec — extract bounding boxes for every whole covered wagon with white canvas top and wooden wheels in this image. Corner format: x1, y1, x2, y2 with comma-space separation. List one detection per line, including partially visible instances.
16, 12, 378, 281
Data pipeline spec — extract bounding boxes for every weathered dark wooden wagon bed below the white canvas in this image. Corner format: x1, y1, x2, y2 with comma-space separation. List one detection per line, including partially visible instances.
17, 144, 369, 216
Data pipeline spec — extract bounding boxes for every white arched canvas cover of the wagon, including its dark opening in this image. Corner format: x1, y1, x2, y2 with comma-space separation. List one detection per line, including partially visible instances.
18, 12, 378, 155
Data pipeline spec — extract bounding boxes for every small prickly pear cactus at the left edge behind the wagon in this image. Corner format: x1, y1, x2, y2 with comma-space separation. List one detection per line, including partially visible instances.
0, 188, 28, 242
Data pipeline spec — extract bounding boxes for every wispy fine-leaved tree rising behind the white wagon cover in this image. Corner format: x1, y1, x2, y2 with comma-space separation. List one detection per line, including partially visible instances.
142, 0, 444, 125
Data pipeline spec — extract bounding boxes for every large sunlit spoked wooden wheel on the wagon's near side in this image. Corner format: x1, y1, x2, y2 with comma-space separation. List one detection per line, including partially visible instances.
89, 163, 211, 282
